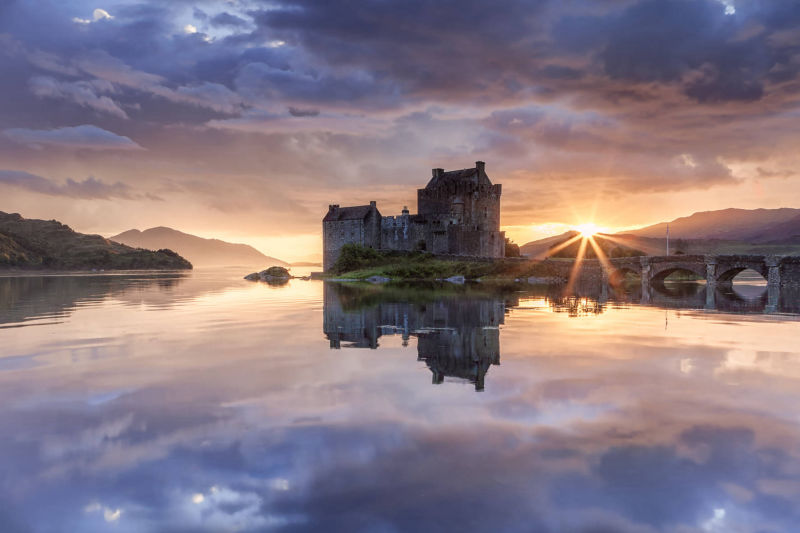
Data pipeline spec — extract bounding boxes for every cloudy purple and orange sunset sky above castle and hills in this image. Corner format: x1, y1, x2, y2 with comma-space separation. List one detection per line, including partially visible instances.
0, 0, 800, 261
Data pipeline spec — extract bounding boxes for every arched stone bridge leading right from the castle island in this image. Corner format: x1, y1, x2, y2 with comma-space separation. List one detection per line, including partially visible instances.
568, 255, 800, 288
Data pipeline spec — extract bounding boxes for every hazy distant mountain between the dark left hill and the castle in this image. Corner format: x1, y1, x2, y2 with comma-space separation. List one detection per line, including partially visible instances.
109, 226, 289, 267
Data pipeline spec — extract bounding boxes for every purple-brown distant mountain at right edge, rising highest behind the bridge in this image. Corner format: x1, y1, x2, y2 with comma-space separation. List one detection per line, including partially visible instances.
625, 208, 800, 243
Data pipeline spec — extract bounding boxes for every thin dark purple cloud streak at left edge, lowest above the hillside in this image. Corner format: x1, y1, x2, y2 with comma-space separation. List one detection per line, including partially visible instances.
0, 170, 136, 200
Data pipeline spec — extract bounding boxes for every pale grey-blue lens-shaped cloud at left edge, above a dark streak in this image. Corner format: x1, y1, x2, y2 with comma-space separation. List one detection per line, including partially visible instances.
3, 124, 142, 150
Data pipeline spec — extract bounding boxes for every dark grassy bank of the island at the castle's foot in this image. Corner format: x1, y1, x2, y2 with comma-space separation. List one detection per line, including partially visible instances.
332, 244, 560, 280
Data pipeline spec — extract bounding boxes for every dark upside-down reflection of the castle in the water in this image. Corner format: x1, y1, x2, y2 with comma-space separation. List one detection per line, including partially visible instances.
323, 283, 519, 391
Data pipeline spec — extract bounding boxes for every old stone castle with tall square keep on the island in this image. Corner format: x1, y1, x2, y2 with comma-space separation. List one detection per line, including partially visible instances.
322, 161, 505, 271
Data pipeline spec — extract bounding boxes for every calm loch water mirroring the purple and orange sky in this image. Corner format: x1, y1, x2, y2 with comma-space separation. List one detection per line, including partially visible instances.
0, 270, 800, 533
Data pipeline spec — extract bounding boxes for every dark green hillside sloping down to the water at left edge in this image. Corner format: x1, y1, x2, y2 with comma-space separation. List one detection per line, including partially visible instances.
0, 212, 192, 270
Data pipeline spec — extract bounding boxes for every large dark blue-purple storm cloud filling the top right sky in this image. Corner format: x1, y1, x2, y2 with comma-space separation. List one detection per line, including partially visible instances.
247, 0, 800, 102
